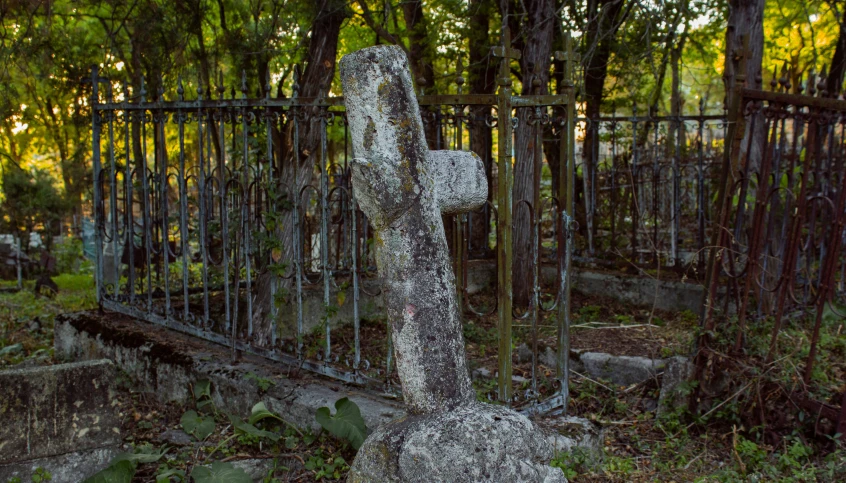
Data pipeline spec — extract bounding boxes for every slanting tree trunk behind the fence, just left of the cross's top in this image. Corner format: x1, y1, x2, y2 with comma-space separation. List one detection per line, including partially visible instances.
253, 0, 349, 347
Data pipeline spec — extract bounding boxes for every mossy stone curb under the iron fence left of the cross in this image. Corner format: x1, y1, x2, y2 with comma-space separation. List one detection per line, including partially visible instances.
53, 312, 405, 431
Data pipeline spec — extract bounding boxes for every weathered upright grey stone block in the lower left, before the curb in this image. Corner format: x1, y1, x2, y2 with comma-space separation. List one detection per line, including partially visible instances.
0, 360, 120, 463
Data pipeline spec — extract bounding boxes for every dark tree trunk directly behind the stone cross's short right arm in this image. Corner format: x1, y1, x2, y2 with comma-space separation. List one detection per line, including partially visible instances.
467, 0, 497, 257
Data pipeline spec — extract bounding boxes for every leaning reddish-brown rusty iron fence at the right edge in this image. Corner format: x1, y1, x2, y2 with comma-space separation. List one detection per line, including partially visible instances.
695, 55, 846, 435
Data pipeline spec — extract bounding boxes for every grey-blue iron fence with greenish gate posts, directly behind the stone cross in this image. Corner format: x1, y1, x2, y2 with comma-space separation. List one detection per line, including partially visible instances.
91, 30, 575, 412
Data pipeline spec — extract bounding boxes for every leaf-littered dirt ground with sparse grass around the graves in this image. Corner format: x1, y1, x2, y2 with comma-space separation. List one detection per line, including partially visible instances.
0, 276, 846, 482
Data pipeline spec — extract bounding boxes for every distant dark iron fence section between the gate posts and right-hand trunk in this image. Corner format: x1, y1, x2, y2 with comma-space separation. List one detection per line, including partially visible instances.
576, 108, 726, 277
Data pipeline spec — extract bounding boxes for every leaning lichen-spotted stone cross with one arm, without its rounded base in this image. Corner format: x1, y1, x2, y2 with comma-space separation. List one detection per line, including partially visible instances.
340, 46, 488, 414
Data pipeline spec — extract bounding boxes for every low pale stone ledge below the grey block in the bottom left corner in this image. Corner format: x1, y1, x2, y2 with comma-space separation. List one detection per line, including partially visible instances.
0, 447, 120, 483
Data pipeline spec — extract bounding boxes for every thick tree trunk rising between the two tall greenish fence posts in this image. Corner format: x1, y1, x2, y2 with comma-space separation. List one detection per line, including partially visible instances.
512, 0, 557, 306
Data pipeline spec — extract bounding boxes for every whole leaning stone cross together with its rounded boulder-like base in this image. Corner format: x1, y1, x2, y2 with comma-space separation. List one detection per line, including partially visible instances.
340, 46, 566, 482
